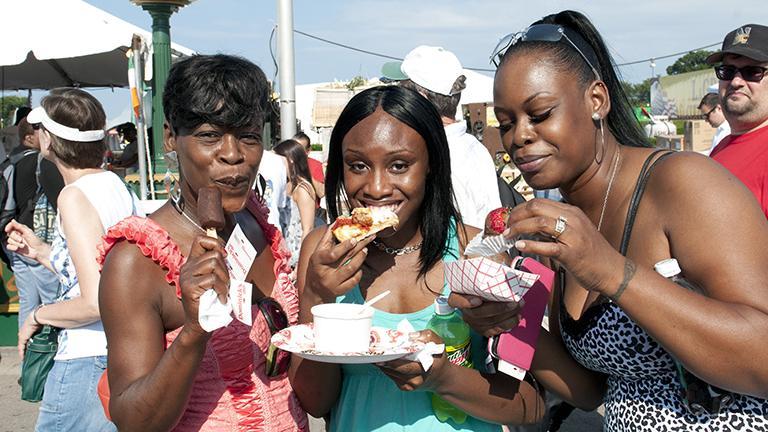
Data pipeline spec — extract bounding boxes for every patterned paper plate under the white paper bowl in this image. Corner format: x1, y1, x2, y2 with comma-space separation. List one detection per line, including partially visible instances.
272, 324, 424, 364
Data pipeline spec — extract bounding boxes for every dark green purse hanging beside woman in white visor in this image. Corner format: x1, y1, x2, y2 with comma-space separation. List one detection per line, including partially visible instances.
19, 325, 59, 402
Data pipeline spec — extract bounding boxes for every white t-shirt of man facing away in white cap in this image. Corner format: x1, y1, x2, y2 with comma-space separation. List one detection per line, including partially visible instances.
445, 121, 501, 229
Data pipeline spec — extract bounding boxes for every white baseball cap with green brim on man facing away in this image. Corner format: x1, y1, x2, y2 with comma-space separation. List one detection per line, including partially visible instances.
381, 45, 464, 96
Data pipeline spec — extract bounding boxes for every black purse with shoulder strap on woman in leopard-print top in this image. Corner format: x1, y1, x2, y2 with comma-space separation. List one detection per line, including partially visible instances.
619, 150, 733, 415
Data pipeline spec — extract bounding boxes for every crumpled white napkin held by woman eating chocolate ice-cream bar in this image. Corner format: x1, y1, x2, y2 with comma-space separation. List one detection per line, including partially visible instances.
197, 279, 253, 332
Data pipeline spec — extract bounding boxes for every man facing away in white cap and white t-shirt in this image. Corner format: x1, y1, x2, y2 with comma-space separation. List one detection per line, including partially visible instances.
382, 45, 501, 228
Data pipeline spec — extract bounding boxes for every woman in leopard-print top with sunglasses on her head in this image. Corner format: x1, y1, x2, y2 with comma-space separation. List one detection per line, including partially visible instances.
453, 11, 768, 431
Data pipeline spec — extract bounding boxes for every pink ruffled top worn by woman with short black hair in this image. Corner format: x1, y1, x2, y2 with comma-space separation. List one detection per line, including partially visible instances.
99, 196, 309, 431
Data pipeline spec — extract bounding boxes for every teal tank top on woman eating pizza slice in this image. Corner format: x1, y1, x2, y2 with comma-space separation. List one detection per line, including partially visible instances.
328, 224, 501, 432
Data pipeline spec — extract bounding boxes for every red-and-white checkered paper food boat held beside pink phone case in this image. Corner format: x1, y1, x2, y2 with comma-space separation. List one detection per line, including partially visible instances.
445, 257, 539, 302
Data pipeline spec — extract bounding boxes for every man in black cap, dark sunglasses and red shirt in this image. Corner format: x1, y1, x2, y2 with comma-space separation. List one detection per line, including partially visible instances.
707, 24, 768, 217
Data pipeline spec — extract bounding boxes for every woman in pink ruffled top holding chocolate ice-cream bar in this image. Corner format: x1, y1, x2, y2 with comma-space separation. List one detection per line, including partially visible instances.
100, 55, 308, 431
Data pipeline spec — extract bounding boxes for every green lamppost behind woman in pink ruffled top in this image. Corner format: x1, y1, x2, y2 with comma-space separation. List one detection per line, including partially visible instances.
131, 0, 194, 172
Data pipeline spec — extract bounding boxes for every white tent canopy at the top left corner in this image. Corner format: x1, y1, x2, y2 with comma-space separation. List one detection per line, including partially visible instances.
0, 0, 194, 90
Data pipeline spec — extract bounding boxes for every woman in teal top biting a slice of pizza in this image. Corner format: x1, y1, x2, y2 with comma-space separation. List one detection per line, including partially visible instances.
291, 82, 544, 431
